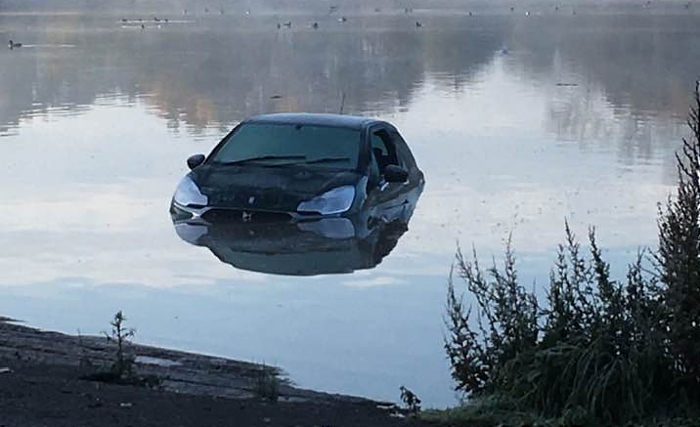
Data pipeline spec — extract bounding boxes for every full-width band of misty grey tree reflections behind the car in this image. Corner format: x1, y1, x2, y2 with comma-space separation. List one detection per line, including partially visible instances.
0, 7, 700, 167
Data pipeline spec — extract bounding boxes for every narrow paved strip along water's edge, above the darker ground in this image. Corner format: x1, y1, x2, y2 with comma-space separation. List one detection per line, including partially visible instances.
0, 316, 378, 405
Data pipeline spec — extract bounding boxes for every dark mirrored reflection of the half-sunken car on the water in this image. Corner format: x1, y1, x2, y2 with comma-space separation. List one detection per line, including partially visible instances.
172, 188, 422, 276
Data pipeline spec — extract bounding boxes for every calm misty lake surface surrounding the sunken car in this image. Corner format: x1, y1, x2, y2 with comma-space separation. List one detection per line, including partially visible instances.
0, 8, 700, 406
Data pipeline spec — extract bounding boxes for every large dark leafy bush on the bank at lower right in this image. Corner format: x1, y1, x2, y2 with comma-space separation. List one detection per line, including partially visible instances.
445, 83, 700, 425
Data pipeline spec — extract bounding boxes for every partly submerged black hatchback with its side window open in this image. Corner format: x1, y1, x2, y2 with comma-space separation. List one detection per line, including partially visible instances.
170, 113, 425, 226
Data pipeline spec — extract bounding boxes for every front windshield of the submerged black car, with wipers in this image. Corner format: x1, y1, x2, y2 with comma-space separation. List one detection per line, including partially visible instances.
212, 123, 360, 170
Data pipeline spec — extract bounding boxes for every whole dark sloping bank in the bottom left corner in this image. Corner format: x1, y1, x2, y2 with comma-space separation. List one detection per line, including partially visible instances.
0, 320, 432, 427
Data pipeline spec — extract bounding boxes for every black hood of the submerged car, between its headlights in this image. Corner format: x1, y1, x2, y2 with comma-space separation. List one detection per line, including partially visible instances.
190, 165, 361, 212
